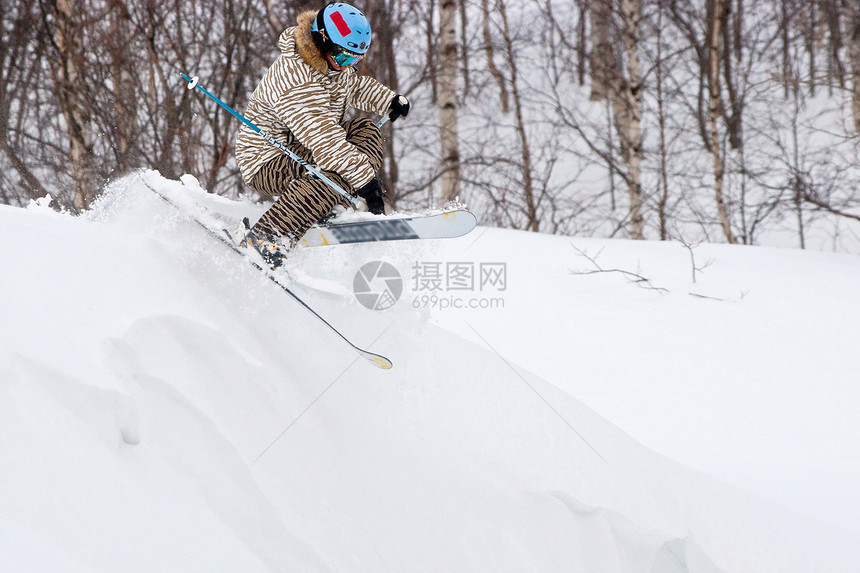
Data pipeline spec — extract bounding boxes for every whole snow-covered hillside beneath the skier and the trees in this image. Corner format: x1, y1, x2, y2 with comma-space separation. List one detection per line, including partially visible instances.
0, 173, 860, 573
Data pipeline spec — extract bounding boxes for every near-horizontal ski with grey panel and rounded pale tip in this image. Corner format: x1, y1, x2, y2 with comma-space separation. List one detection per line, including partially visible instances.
297, 209, 478, 247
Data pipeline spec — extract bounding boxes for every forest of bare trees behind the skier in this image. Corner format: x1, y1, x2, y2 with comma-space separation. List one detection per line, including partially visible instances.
0, 0, 860, 252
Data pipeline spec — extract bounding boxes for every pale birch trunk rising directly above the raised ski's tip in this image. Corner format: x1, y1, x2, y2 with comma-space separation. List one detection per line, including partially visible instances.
438, 0, 460, 201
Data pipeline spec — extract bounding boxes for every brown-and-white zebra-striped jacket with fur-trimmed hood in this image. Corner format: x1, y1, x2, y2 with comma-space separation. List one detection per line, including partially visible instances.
236, 11, 395, 188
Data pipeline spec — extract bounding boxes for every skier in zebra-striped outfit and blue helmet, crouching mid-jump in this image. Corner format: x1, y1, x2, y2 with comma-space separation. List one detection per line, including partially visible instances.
236, 2, 410, 266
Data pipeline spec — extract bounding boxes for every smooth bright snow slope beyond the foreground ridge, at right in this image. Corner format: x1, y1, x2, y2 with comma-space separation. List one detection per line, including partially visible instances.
424, 223, 860, 534
